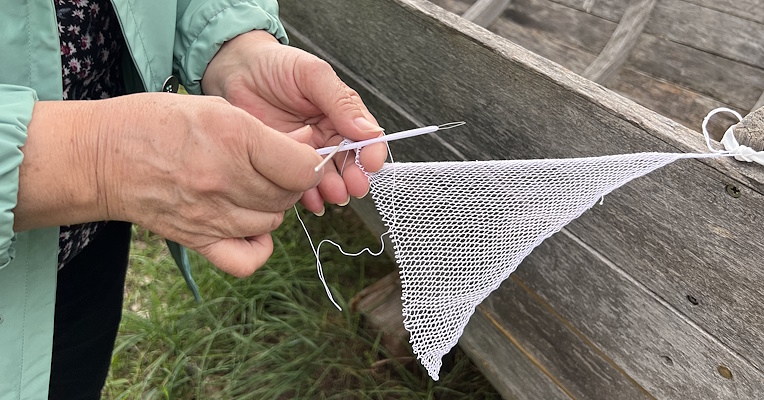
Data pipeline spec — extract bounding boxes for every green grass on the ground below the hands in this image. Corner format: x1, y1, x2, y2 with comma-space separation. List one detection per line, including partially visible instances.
104, 208, 498, 400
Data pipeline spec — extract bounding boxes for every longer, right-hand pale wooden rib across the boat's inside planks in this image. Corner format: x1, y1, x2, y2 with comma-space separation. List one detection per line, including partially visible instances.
583, 0, 657, 84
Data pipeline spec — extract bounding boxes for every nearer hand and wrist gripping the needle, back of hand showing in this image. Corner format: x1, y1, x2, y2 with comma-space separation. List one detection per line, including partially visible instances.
14, 93, 322, 276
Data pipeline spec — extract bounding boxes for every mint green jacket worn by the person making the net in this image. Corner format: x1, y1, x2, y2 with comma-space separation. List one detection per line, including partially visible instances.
0, 0, 286, 400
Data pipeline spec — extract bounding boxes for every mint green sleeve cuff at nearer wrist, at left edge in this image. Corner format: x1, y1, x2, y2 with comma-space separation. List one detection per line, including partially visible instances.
0, 84, 37, 269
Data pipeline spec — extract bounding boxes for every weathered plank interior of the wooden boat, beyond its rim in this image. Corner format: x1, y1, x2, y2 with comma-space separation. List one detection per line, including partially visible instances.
432, 0, 764, 134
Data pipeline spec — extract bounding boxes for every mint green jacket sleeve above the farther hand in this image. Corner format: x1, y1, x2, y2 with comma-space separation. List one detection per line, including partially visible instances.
173, 0, 288, 94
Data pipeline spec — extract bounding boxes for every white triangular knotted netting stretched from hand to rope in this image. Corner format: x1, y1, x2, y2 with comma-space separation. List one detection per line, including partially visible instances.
367, 153, 702, 380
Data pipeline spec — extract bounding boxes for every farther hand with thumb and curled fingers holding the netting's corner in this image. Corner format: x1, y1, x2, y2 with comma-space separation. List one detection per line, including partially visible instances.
202, 31, 387, 214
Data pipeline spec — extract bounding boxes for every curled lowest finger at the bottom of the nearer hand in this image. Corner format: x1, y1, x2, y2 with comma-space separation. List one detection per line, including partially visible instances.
199, 233, 273, 278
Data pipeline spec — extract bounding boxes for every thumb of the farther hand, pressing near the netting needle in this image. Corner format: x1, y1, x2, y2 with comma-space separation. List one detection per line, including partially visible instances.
294, 56, 382, 141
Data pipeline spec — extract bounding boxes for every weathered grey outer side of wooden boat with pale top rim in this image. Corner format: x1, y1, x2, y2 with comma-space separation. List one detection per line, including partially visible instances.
280, 0, 764, 399
